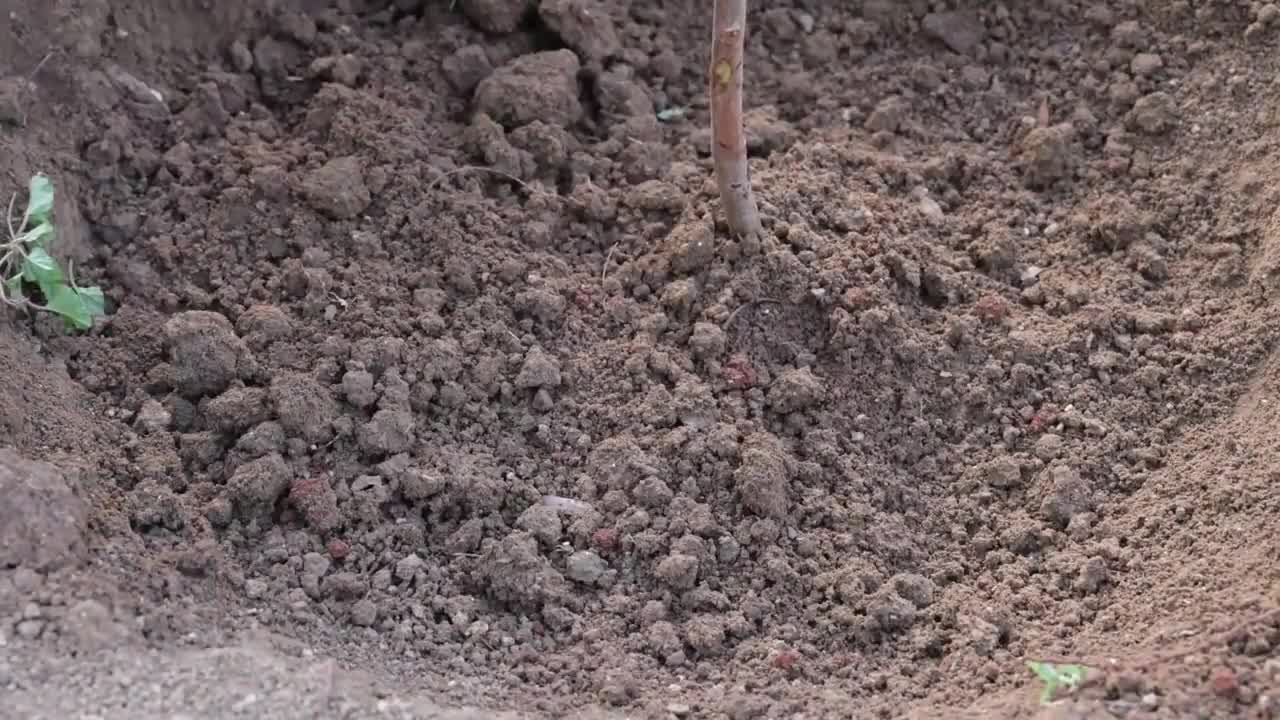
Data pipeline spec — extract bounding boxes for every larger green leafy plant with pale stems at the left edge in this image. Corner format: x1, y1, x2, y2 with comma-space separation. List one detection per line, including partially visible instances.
0, 173, 105, 331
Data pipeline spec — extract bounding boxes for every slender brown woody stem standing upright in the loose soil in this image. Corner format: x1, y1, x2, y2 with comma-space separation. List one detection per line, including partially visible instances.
710, 0, 762, 236
